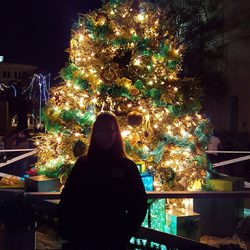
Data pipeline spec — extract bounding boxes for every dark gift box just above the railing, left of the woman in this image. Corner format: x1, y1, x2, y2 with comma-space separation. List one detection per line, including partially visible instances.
25, 175, 60, 192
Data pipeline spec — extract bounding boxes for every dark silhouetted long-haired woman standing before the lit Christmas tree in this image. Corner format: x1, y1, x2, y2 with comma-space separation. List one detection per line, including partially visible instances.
59, 112, 147, 250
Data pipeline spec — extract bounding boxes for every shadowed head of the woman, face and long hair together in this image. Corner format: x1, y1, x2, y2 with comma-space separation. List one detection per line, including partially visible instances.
88, 112, 125, 157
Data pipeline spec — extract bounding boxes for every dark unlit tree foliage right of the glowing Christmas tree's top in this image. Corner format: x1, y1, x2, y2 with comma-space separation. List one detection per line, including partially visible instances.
155, 0, 227, 98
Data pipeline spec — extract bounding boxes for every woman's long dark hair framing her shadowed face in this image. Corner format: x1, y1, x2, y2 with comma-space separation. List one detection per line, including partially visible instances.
87, 112, 126, 158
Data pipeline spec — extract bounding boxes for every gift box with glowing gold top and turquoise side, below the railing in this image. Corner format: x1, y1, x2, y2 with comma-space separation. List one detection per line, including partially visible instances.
166, 208, 201, 241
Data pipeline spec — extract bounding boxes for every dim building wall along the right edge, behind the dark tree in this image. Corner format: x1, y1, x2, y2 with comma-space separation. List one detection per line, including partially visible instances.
207, 0, 250, 144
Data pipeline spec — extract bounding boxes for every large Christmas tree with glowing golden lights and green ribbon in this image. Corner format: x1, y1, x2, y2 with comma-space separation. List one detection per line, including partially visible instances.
36, 0, 210, 191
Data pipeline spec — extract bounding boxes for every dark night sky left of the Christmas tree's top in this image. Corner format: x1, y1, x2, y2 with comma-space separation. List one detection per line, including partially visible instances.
0, 0, 102, 76
